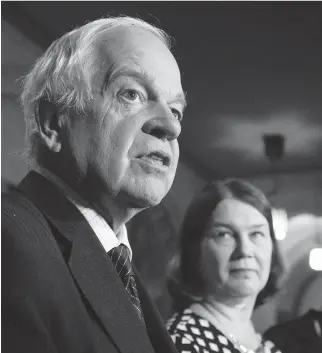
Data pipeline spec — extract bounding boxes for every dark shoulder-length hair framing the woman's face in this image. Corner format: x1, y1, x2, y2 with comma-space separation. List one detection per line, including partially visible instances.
168, 179, 284, 309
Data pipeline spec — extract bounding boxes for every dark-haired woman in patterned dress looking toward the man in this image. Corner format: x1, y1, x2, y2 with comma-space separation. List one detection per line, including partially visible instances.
167, 179, 283, 353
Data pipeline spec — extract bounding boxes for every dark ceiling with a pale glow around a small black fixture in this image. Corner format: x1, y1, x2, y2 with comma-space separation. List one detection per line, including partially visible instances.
2, 1, 322, 179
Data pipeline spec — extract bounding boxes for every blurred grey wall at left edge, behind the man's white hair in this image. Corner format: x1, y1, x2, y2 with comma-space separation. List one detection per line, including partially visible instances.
1, 20, 43, 187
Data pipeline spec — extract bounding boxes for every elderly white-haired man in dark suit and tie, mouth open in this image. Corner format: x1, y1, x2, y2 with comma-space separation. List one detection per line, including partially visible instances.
2, 17, 186, 353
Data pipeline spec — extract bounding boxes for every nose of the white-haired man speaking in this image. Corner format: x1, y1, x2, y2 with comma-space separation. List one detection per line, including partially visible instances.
142, 103, 181, 141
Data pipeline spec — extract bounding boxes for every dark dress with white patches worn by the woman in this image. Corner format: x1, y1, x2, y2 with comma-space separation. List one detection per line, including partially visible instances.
167, 308, 281, 353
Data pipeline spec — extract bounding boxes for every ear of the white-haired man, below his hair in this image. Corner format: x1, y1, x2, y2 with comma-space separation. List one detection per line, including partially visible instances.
35, 99, 64, 152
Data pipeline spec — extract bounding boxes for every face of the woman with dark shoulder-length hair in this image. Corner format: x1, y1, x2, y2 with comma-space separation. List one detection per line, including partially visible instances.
201, 199, 273, 298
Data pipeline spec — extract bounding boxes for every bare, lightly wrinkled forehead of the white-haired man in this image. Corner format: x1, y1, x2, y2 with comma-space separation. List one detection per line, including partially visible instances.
95, 27, 186, 102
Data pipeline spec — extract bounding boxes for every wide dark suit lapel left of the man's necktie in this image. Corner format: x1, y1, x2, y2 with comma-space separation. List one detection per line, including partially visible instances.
18, 172, 153, 353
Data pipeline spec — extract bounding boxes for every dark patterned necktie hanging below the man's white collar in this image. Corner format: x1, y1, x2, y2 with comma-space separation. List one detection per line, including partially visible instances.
108, 244, 144, 321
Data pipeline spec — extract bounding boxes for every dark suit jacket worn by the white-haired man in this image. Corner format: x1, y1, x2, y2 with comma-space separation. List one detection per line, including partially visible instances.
2, 172, 176, 353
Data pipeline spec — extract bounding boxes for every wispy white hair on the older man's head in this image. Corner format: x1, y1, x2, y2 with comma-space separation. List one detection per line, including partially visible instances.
21, 16, 171, 157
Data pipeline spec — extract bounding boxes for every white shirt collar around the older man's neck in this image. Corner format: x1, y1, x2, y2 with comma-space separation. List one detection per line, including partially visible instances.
35, 166, 132, 259
